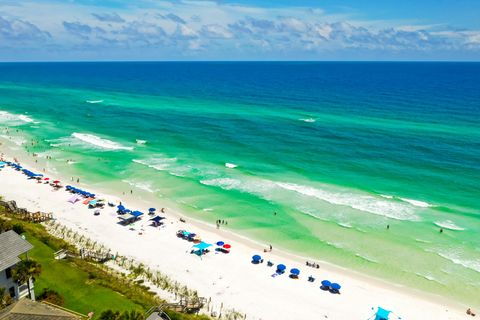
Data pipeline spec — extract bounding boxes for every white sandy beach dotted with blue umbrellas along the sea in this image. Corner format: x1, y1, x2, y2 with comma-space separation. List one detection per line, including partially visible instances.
0, 153, 471, 320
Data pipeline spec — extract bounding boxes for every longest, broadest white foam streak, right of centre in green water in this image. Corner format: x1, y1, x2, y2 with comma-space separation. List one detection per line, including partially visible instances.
277, 183, 419, 221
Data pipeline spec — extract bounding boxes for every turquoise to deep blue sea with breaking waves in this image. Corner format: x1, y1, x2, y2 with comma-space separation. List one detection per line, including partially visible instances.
0, 63, 480, 305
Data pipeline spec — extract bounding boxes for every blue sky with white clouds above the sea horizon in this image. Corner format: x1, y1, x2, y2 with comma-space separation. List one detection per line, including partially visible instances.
0, 0, 480, 61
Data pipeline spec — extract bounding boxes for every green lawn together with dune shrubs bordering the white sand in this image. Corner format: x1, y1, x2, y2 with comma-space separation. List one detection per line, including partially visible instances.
0, 207, 210, 320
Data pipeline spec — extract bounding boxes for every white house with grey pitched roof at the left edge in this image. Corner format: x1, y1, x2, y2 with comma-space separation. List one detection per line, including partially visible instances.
0, 230, 35, 300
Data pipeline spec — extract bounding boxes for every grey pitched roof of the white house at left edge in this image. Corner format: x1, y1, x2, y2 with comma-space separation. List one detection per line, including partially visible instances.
0, 230, 33, 271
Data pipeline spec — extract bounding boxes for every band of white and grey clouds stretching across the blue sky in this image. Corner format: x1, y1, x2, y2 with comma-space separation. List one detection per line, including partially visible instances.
0, 0, 480, 57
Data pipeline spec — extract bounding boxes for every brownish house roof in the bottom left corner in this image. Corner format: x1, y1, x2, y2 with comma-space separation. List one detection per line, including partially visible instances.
0, 299, 82, 320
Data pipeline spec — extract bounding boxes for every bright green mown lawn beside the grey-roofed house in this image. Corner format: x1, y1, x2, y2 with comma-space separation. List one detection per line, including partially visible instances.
25, 231, 144, 316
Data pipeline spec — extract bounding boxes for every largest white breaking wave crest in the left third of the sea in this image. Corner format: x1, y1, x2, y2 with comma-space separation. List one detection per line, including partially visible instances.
49, 132, 133, 151
